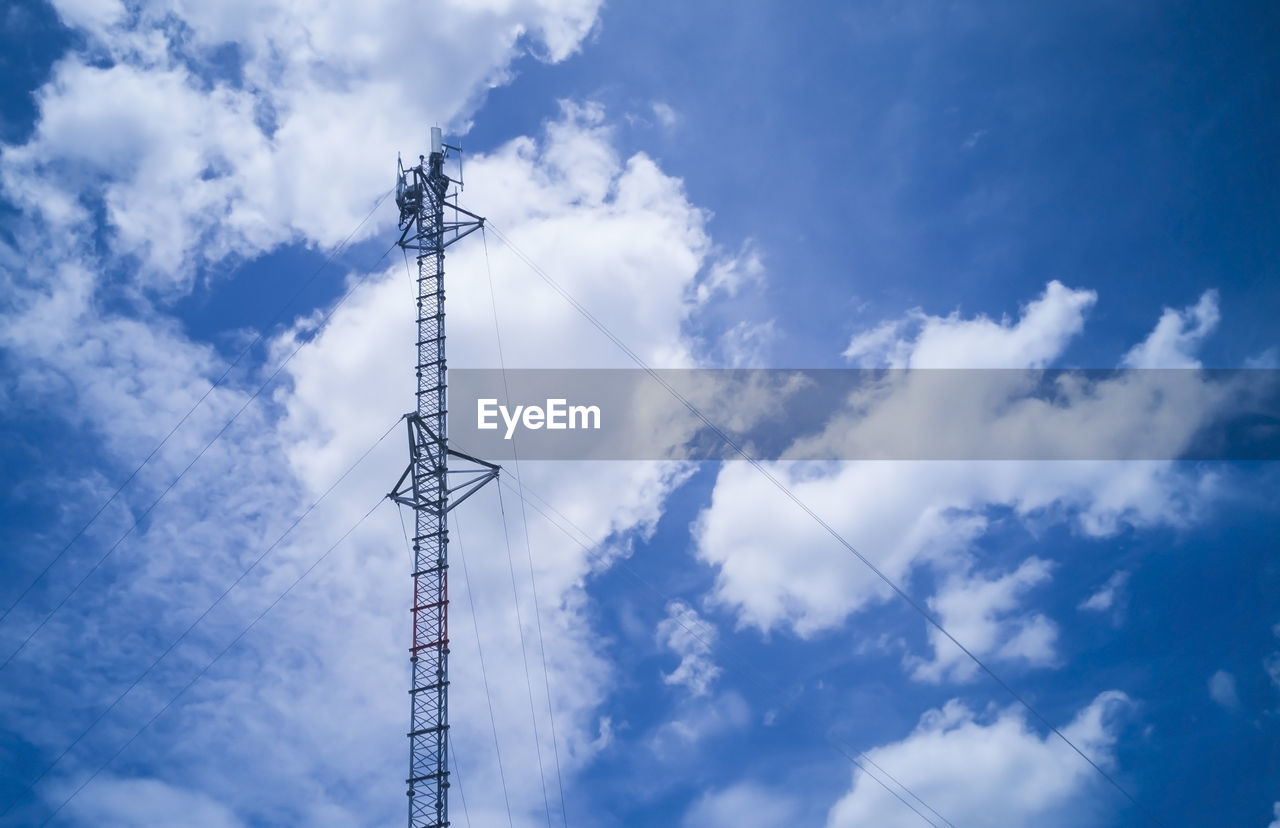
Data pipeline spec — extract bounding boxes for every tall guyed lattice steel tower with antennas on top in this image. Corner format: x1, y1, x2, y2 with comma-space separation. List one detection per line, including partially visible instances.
388, 127, 498, 828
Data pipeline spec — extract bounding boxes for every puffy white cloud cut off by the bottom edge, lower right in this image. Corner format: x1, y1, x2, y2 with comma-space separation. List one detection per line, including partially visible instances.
827, 690, 1128, 828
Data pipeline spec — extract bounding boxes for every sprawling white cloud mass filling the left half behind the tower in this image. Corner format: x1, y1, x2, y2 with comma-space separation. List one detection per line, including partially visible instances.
0, 3, 746, 824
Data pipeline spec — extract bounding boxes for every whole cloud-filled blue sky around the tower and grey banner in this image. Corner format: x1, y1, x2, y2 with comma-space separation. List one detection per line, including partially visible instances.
0, 0, 1280, 828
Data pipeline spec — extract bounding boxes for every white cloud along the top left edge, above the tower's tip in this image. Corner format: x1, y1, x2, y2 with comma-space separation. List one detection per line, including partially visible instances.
0, 0, 599, 294
